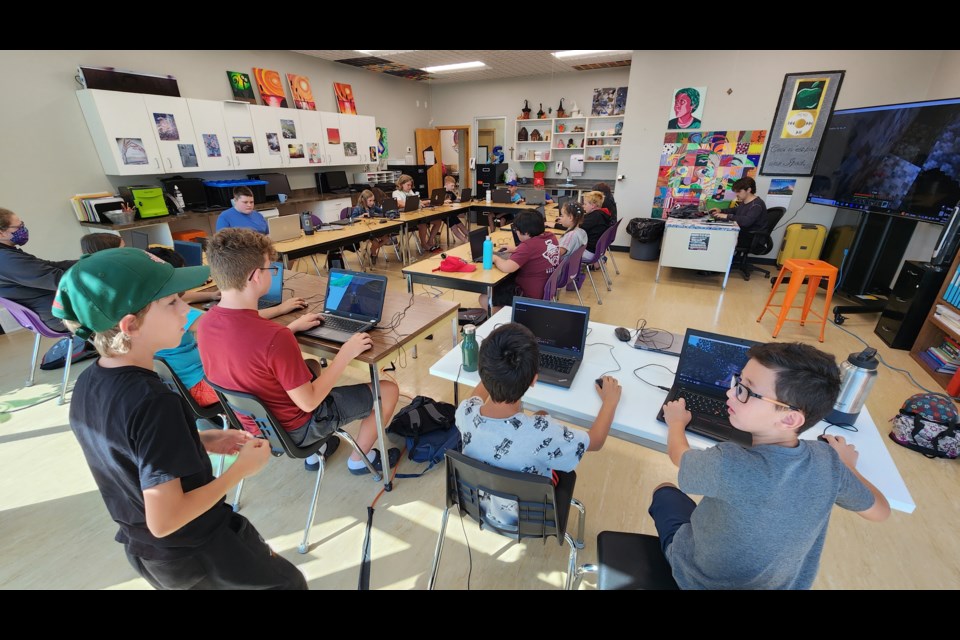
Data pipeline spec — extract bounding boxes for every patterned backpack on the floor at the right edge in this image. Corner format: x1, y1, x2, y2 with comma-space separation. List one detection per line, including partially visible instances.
890, 393, 960, 459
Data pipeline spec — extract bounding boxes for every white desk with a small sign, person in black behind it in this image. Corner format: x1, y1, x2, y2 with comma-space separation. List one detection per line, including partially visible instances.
657, 218, 740, 289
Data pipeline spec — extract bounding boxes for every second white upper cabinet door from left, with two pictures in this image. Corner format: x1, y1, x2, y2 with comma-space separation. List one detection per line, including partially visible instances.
143, 94, 207, 173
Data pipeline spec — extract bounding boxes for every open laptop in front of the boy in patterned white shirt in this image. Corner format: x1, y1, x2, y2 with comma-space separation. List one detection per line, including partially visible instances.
512, 296, 590, 389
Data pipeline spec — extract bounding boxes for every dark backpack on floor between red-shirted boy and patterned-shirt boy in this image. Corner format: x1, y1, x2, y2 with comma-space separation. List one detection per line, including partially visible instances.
387, 396, 462, 478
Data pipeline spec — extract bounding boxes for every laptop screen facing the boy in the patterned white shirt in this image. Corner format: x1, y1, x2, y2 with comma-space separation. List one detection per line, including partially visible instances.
513, 296, 590, 357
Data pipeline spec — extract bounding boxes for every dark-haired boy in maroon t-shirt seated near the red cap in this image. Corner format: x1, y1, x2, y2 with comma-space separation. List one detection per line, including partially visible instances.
480, 209, 560, 313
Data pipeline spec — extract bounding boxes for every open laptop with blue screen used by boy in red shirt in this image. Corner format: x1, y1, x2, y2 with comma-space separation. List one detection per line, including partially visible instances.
305, 269, 387, 342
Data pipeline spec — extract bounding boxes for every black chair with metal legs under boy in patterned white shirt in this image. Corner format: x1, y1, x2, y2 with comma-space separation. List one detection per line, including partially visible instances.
428, 451, 586, 589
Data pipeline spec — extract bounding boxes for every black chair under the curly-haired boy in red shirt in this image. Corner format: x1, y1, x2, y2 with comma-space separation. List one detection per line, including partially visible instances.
207, 380, 380, 553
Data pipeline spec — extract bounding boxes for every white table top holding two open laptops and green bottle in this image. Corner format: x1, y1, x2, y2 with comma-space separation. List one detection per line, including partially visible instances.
430, 307, 916, 513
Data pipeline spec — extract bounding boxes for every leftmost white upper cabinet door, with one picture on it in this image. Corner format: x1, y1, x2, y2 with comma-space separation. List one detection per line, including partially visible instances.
77, 89, 165, 176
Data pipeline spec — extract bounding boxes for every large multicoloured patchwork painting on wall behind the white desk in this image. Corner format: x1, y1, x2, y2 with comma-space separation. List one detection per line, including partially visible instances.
651, 130, 767, 218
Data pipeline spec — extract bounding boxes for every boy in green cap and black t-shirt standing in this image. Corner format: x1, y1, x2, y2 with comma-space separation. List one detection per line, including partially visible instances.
53, 248, 307, 589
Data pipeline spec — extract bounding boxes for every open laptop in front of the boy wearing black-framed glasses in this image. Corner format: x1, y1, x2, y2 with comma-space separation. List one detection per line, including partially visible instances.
657, 329, 759, 447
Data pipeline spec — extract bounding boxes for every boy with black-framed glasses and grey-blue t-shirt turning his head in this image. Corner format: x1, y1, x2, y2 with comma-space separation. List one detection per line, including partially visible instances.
650, 342, 890, 589
